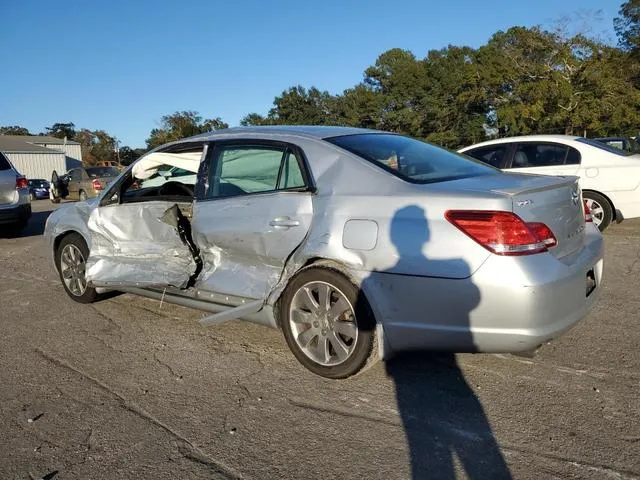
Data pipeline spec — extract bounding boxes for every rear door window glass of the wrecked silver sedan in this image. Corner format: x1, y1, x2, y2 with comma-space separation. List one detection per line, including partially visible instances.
206, 145, 305, 198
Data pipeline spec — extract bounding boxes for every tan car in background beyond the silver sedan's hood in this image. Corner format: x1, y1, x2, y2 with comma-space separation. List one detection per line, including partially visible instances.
51, 167, 120, 203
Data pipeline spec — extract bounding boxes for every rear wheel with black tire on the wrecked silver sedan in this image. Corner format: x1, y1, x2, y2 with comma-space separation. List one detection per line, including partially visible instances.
279, 267, 376, 379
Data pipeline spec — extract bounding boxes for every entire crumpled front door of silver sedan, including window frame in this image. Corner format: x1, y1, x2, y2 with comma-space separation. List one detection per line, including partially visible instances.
81, 142, 206, 288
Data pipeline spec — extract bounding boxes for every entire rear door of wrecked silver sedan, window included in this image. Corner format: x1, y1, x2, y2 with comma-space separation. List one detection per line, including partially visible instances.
192, 140, 313, 300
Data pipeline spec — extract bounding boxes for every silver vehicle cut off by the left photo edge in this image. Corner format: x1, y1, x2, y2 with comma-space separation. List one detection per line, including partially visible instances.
0, 153, 31, 233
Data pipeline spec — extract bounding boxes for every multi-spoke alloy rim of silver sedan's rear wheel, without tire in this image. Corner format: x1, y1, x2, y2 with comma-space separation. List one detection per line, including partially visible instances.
289, 281, 358, 366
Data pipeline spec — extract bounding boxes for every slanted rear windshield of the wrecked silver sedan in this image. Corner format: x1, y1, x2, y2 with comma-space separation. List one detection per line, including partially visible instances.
326, 133, 499, 183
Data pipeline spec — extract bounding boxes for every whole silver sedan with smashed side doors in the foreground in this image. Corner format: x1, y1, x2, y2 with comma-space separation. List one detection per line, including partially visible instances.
44, 126, 603, 378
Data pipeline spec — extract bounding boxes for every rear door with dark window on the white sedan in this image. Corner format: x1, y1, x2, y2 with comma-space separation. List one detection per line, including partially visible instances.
506, 142, 580, 175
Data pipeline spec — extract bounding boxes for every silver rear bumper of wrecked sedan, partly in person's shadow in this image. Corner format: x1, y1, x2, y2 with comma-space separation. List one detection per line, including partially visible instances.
363, 227, 604, 353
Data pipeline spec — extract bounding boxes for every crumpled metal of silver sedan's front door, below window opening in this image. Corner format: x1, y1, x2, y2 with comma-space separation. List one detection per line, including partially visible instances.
86, 202, 196, 288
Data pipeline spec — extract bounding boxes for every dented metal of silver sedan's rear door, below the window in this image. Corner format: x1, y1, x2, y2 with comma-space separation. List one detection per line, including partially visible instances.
191, 192, 313, 299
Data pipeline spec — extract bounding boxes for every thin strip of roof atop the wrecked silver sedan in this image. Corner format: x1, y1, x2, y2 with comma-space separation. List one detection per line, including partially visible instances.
184, 125, 384, 140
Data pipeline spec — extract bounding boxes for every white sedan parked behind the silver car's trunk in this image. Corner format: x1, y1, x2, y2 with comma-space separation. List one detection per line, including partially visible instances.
459, 135, 640, 231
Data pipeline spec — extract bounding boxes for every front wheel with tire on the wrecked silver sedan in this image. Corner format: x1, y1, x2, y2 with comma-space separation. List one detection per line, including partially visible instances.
55, 233, 98, 303
